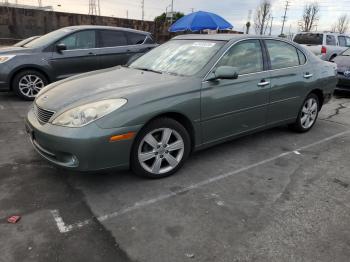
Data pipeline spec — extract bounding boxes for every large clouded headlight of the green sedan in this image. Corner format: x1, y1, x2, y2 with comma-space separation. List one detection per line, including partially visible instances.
52, 98, 127, 127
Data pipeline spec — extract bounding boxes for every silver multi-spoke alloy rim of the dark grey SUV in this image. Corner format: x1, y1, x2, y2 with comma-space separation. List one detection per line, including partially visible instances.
18, 75, 45, 98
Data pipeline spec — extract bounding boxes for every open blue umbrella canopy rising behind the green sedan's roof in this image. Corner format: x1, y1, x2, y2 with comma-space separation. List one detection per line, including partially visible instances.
169, 11, 233, 32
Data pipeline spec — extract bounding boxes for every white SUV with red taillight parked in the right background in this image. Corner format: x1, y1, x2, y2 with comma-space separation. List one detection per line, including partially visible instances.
294, 32, 350, 61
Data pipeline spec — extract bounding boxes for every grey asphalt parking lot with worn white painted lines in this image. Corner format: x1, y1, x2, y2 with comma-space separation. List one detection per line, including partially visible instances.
0, 93, 350, 262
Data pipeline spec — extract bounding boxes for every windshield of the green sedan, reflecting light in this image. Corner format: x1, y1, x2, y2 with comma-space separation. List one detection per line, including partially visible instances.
130, 40, 226, 76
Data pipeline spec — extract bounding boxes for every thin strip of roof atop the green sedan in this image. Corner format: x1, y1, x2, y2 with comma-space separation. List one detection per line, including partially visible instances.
173, 34, 290, 42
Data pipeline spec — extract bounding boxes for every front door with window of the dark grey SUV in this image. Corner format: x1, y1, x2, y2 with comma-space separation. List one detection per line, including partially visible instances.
50, 30, 99, 80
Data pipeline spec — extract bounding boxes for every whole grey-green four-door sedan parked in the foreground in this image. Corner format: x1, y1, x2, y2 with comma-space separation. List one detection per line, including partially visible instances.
26, 34, 337, 178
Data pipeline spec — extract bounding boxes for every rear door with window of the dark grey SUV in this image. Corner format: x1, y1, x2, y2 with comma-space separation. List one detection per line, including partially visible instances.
97, 30, 131, 68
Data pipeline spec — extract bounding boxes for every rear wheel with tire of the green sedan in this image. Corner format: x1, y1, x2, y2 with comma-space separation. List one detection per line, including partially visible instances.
290, 93, 320, 133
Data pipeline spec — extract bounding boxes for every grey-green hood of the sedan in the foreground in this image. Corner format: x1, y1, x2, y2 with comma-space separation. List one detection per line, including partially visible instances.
35, 67, 186, 112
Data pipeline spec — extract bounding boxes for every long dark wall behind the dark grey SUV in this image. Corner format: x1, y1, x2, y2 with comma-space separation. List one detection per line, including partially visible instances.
0, 6, 171, 44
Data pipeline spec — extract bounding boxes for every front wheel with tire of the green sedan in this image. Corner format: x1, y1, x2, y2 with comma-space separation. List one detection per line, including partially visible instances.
130, 118, 191, 178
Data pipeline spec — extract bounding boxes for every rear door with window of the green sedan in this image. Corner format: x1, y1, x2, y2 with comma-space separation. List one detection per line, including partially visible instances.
264, 40, 308, 125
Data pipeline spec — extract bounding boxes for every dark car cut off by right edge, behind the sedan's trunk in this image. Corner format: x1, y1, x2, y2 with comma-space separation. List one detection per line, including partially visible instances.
334, 49, 350, 91
